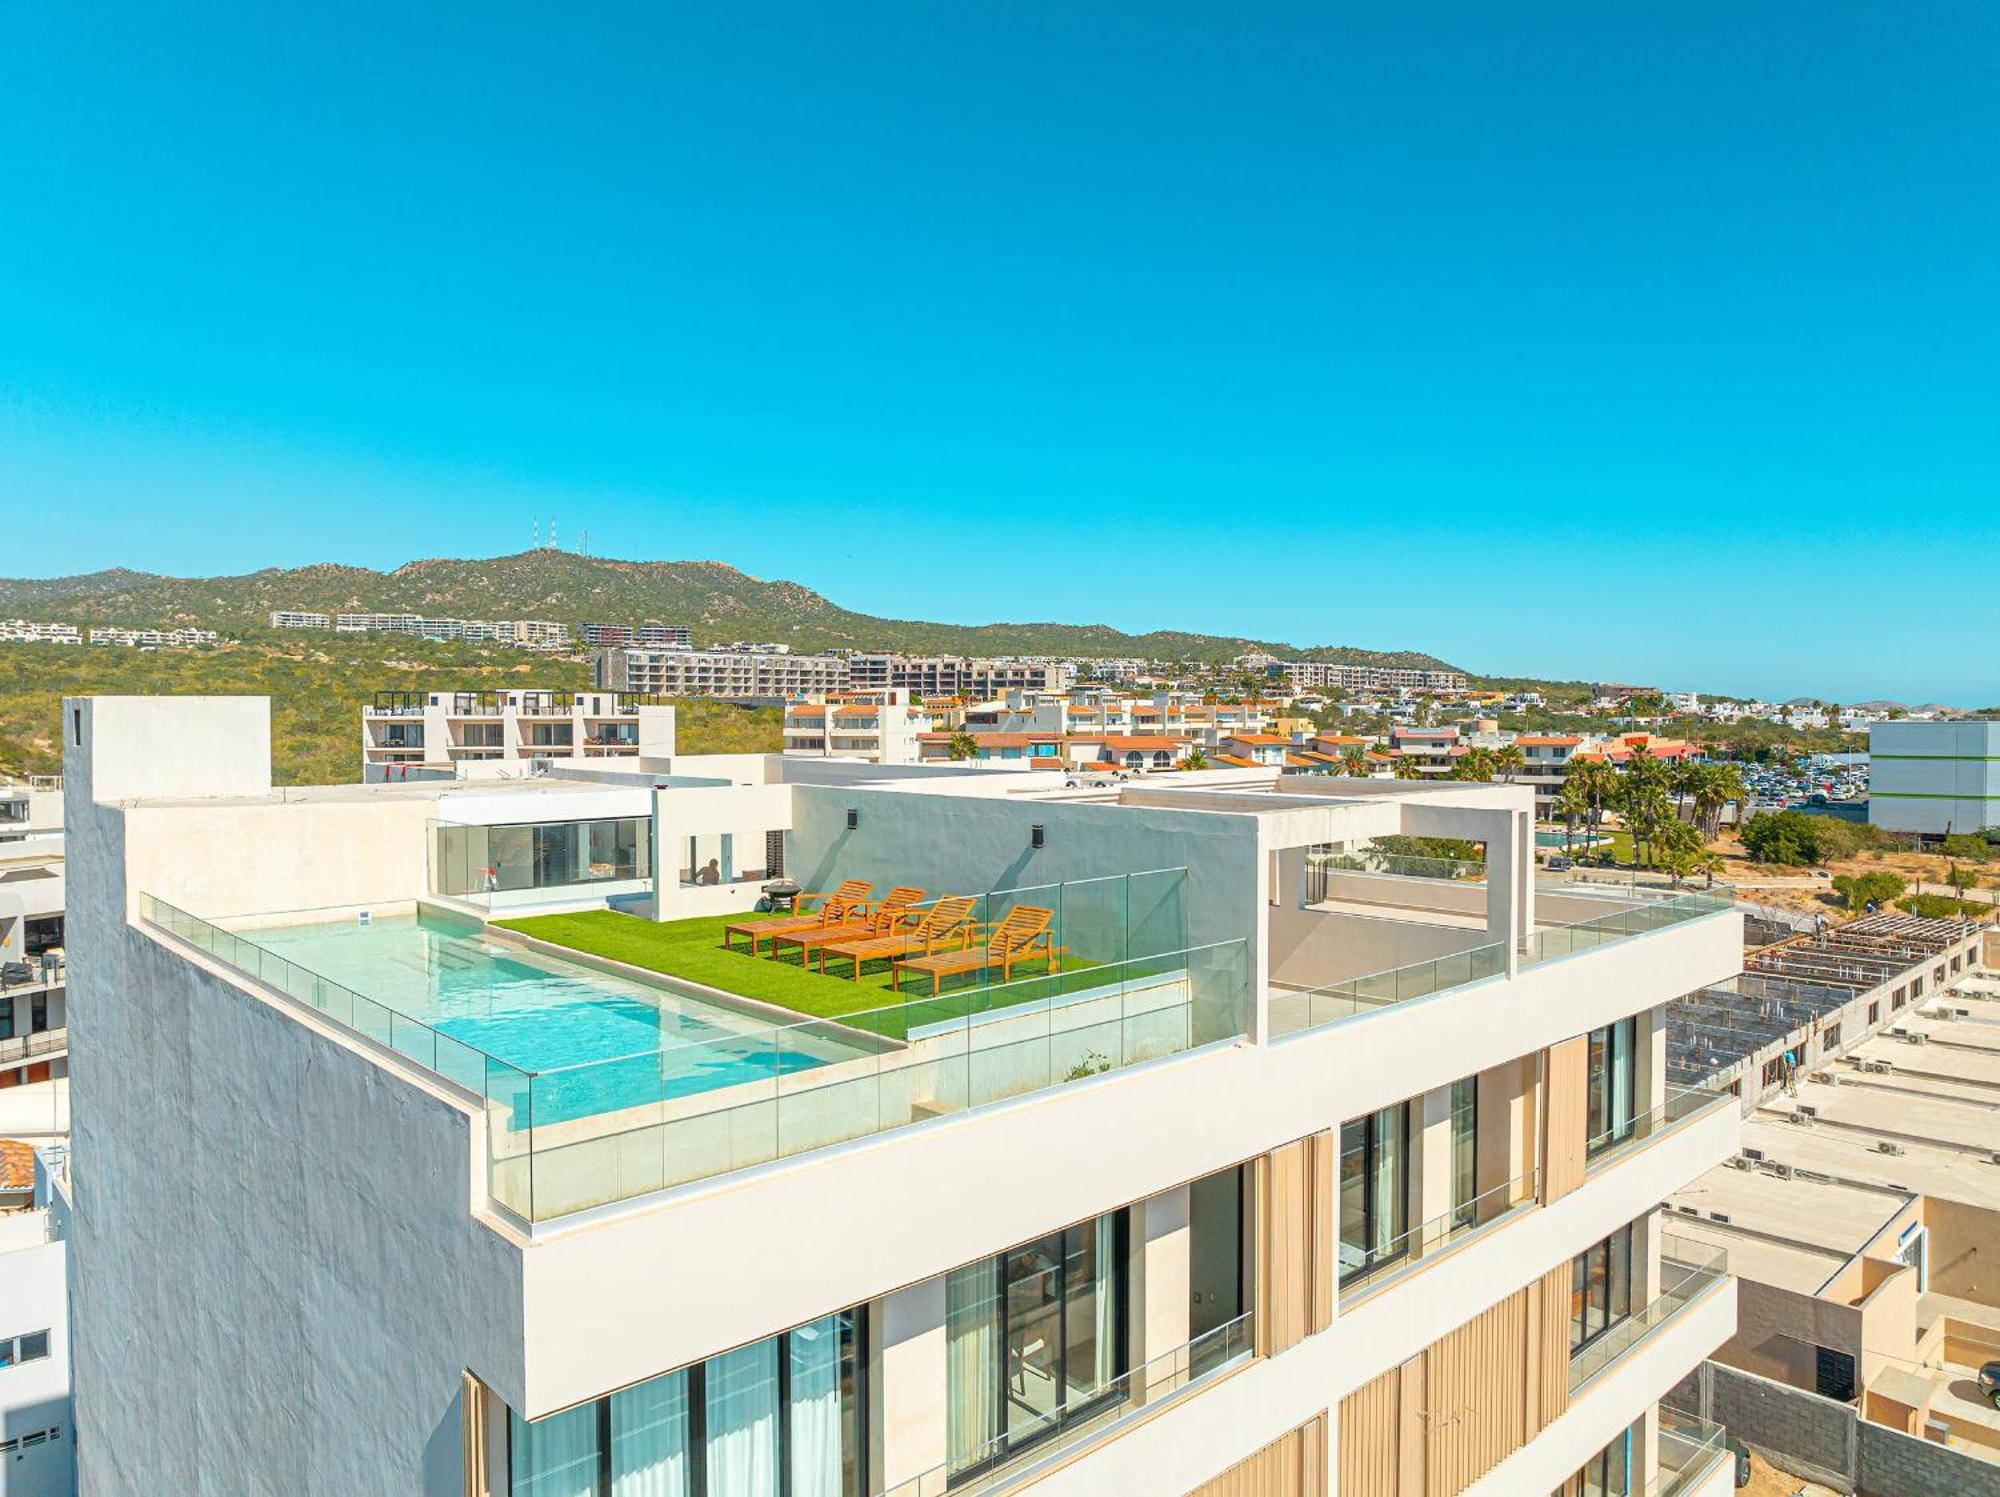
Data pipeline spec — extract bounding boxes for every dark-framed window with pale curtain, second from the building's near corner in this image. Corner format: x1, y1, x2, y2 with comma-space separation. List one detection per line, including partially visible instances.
944, 1211, 1126, 1479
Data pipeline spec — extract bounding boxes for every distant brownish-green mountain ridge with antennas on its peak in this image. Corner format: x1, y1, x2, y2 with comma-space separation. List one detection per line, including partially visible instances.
0, 548, 1472, 668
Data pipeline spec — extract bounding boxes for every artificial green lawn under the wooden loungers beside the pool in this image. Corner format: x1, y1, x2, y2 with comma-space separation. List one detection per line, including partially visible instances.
494, 911, 1104, 1039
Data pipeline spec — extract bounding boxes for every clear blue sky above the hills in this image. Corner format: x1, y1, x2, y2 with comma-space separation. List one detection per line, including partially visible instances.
0, 0, 2000, 704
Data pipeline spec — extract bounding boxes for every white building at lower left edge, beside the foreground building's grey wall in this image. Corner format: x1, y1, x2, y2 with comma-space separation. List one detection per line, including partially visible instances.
0, 1139, 76, 1497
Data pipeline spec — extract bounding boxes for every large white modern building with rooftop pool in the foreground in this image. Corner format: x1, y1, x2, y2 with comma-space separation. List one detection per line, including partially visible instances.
64, 698, 1742, 1497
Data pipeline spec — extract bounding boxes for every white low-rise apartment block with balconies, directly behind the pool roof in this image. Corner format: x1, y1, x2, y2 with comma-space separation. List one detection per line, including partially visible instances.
362, 690, 674, 779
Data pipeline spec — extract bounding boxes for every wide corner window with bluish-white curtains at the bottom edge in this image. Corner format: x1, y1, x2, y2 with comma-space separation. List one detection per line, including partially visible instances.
508, 1311, 868, 1497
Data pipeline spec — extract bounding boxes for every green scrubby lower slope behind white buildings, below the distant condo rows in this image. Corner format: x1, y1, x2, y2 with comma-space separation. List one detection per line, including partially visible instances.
0, 634, 784, 785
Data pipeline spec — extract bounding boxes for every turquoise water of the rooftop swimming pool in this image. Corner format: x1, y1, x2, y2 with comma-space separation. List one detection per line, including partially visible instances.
238, 915, 844, 1127
